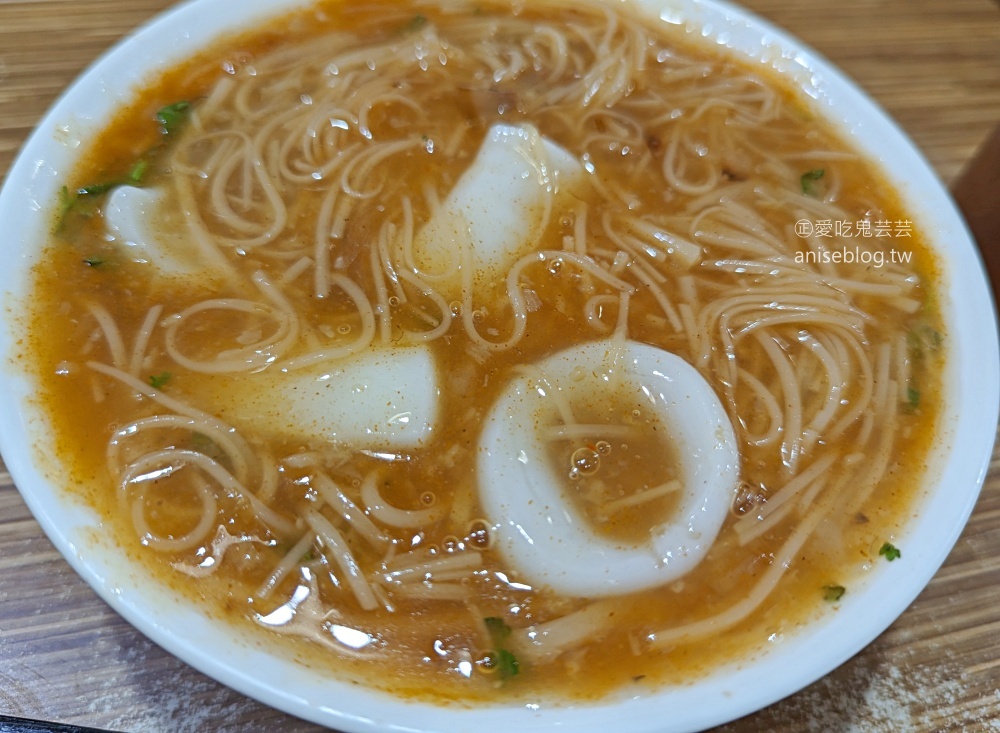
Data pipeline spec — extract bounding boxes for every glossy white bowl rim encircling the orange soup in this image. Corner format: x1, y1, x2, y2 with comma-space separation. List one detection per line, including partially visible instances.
0, 0, 1000, 733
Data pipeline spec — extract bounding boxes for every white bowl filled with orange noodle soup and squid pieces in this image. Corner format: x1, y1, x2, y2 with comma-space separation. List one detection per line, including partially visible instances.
0, 0, 1000, 731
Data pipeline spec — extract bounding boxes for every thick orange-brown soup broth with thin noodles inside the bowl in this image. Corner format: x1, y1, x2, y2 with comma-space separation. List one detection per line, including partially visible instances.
29, 0, 943, 701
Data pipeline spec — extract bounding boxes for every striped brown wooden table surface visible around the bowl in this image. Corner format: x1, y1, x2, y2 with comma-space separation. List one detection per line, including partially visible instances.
0, 0, 1000, 733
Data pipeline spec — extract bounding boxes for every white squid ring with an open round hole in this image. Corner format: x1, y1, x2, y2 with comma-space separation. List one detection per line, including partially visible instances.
478, 340, 739, 597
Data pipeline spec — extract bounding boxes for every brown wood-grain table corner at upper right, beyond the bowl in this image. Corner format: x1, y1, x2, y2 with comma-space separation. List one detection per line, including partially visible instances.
743, 0, 1000, 183
